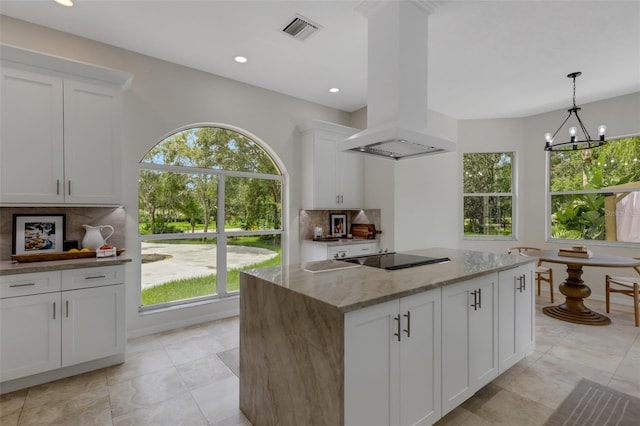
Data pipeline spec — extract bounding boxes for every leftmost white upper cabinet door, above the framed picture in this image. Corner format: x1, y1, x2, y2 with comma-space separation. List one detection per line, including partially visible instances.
0, 63, 64, 203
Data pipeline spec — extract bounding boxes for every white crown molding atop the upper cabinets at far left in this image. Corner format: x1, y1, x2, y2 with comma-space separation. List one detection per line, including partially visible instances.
0, 43, 133, 88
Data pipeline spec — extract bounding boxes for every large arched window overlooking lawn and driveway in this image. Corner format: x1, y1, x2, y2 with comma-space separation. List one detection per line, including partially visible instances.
138, 125, 284, 310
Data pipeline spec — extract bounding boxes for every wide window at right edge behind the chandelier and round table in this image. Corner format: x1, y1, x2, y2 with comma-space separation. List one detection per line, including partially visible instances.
548, 136, 640, 243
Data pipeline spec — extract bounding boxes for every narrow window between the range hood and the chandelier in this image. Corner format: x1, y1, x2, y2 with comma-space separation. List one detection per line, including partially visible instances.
462, 152, 514, 239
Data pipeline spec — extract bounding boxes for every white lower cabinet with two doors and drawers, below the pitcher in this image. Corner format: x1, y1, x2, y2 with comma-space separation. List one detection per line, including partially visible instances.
0, 266, 126, 382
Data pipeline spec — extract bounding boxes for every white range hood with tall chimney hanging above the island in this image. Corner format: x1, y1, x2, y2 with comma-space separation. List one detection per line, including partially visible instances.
338, 0, 456, 160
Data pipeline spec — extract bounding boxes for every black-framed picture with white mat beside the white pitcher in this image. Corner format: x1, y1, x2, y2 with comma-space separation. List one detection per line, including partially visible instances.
13, 214, 67, 254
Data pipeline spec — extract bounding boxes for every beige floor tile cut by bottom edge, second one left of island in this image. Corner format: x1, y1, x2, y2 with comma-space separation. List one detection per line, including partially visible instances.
113, 393, 207, 426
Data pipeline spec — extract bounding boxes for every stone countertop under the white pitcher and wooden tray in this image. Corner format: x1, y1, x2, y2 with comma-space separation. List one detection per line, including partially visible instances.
0, 254, 131, 276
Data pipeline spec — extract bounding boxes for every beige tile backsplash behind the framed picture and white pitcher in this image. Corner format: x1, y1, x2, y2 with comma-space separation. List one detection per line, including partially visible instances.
0, 207, 126, 260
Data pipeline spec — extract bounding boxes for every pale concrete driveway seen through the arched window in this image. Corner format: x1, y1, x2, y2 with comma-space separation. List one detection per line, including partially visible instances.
142, 242, 278, 289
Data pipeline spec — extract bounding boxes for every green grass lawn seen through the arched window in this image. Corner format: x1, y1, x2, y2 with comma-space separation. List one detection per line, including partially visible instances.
141, 236, 282, 306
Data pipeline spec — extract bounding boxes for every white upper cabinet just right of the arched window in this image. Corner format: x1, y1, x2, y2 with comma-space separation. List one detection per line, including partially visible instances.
300, 120, 364, 209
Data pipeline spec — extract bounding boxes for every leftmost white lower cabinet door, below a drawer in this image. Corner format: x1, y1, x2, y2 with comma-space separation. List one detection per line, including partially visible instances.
0, 292, 60, 381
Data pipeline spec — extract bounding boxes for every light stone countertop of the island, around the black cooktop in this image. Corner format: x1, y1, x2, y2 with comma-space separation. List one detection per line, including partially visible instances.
242, 248, 537, 312
